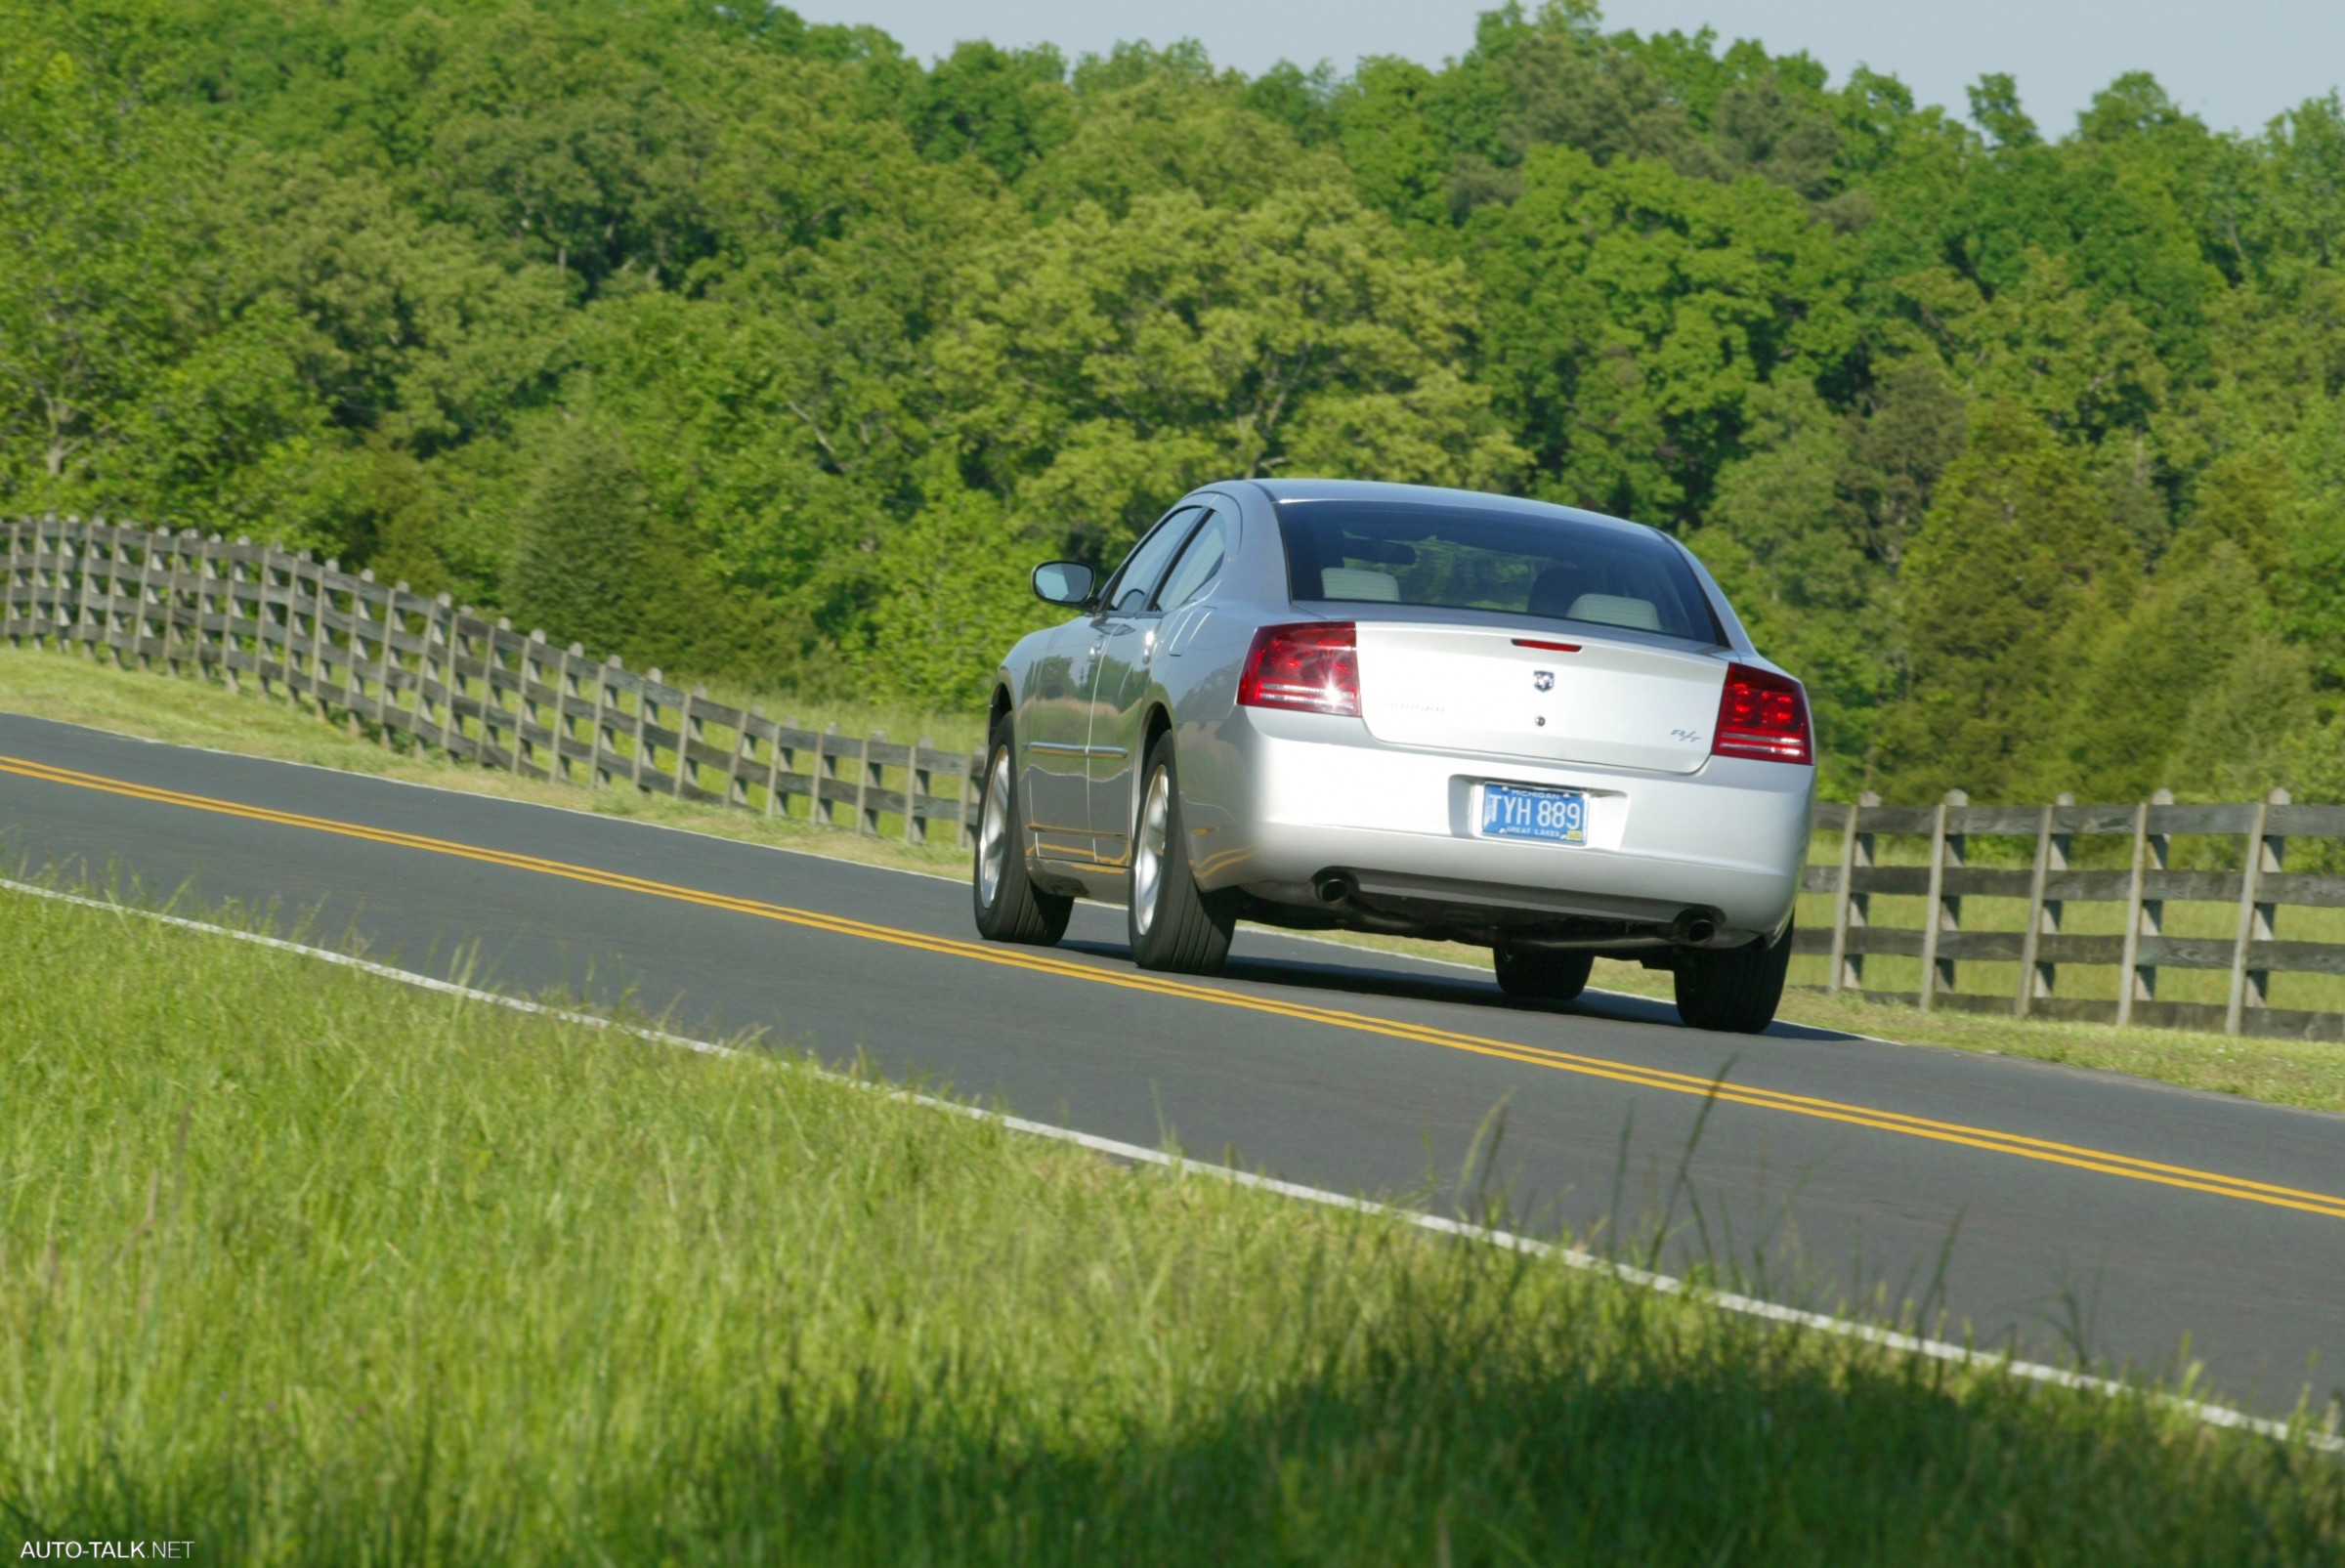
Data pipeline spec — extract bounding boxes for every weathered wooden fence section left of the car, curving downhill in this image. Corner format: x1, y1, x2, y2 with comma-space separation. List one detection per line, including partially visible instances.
0, 518, 985, 844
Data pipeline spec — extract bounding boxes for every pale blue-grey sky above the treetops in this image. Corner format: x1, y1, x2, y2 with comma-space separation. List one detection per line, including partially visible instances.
786, 0, 2345, 136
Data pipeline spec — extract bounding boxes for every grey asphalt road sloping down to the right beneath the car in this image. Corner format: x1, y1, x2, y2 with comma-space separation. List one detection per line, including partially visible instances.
0, 715, 2345, 1411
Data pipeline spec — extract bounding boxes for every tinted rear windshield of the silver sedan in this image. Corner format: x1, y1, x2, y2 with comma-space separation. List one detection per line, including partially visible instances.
1278, 501, 1726, 642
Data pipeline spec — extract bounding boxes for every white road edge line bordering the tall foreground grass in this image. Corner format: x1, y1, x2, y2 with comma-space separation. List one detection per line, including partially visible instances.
0, 876, 2345, 1453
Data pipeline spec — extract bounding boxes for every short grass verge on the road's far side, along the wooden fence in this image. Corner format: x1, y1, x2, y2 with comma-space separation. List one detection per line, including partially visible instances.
14, 647, 2345, 1111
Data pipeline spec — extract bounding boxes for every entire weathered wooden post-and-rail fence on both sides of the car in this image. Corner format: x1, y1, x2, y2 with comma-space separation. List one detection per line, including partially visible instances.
14, 516, 2345, 1038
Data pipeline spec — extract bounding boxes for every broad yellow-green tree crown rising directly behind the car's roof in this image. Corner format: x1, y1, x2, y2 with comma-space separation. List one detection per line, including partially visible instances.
936, 186, 1519, 556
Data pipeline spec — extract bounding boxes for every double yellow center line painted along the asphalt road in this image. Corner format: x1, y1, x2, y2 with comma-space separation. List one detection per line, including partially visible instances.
0, 757, 2345, 1219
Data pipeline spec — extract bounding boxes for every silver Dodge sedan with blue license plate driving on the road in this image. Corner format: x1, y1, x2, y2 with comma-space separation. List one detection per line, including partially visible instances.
973, 481, 1815, 1032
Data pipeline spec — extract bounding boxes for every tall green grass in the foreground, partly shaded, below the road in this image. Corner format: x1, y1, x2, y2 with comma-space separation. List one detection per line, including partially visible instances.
0, 893, 2345, 1568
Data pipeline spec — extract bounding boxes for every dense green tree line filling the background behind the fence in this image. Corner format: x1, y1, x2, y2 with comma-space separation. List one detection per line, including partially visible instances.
0, 0, 2345, 799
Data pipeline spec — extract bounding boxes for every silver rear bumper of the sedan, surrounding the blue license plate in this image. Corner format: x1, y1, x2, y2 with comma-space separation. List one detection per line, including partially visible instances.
1182, 708, 1815, 945
